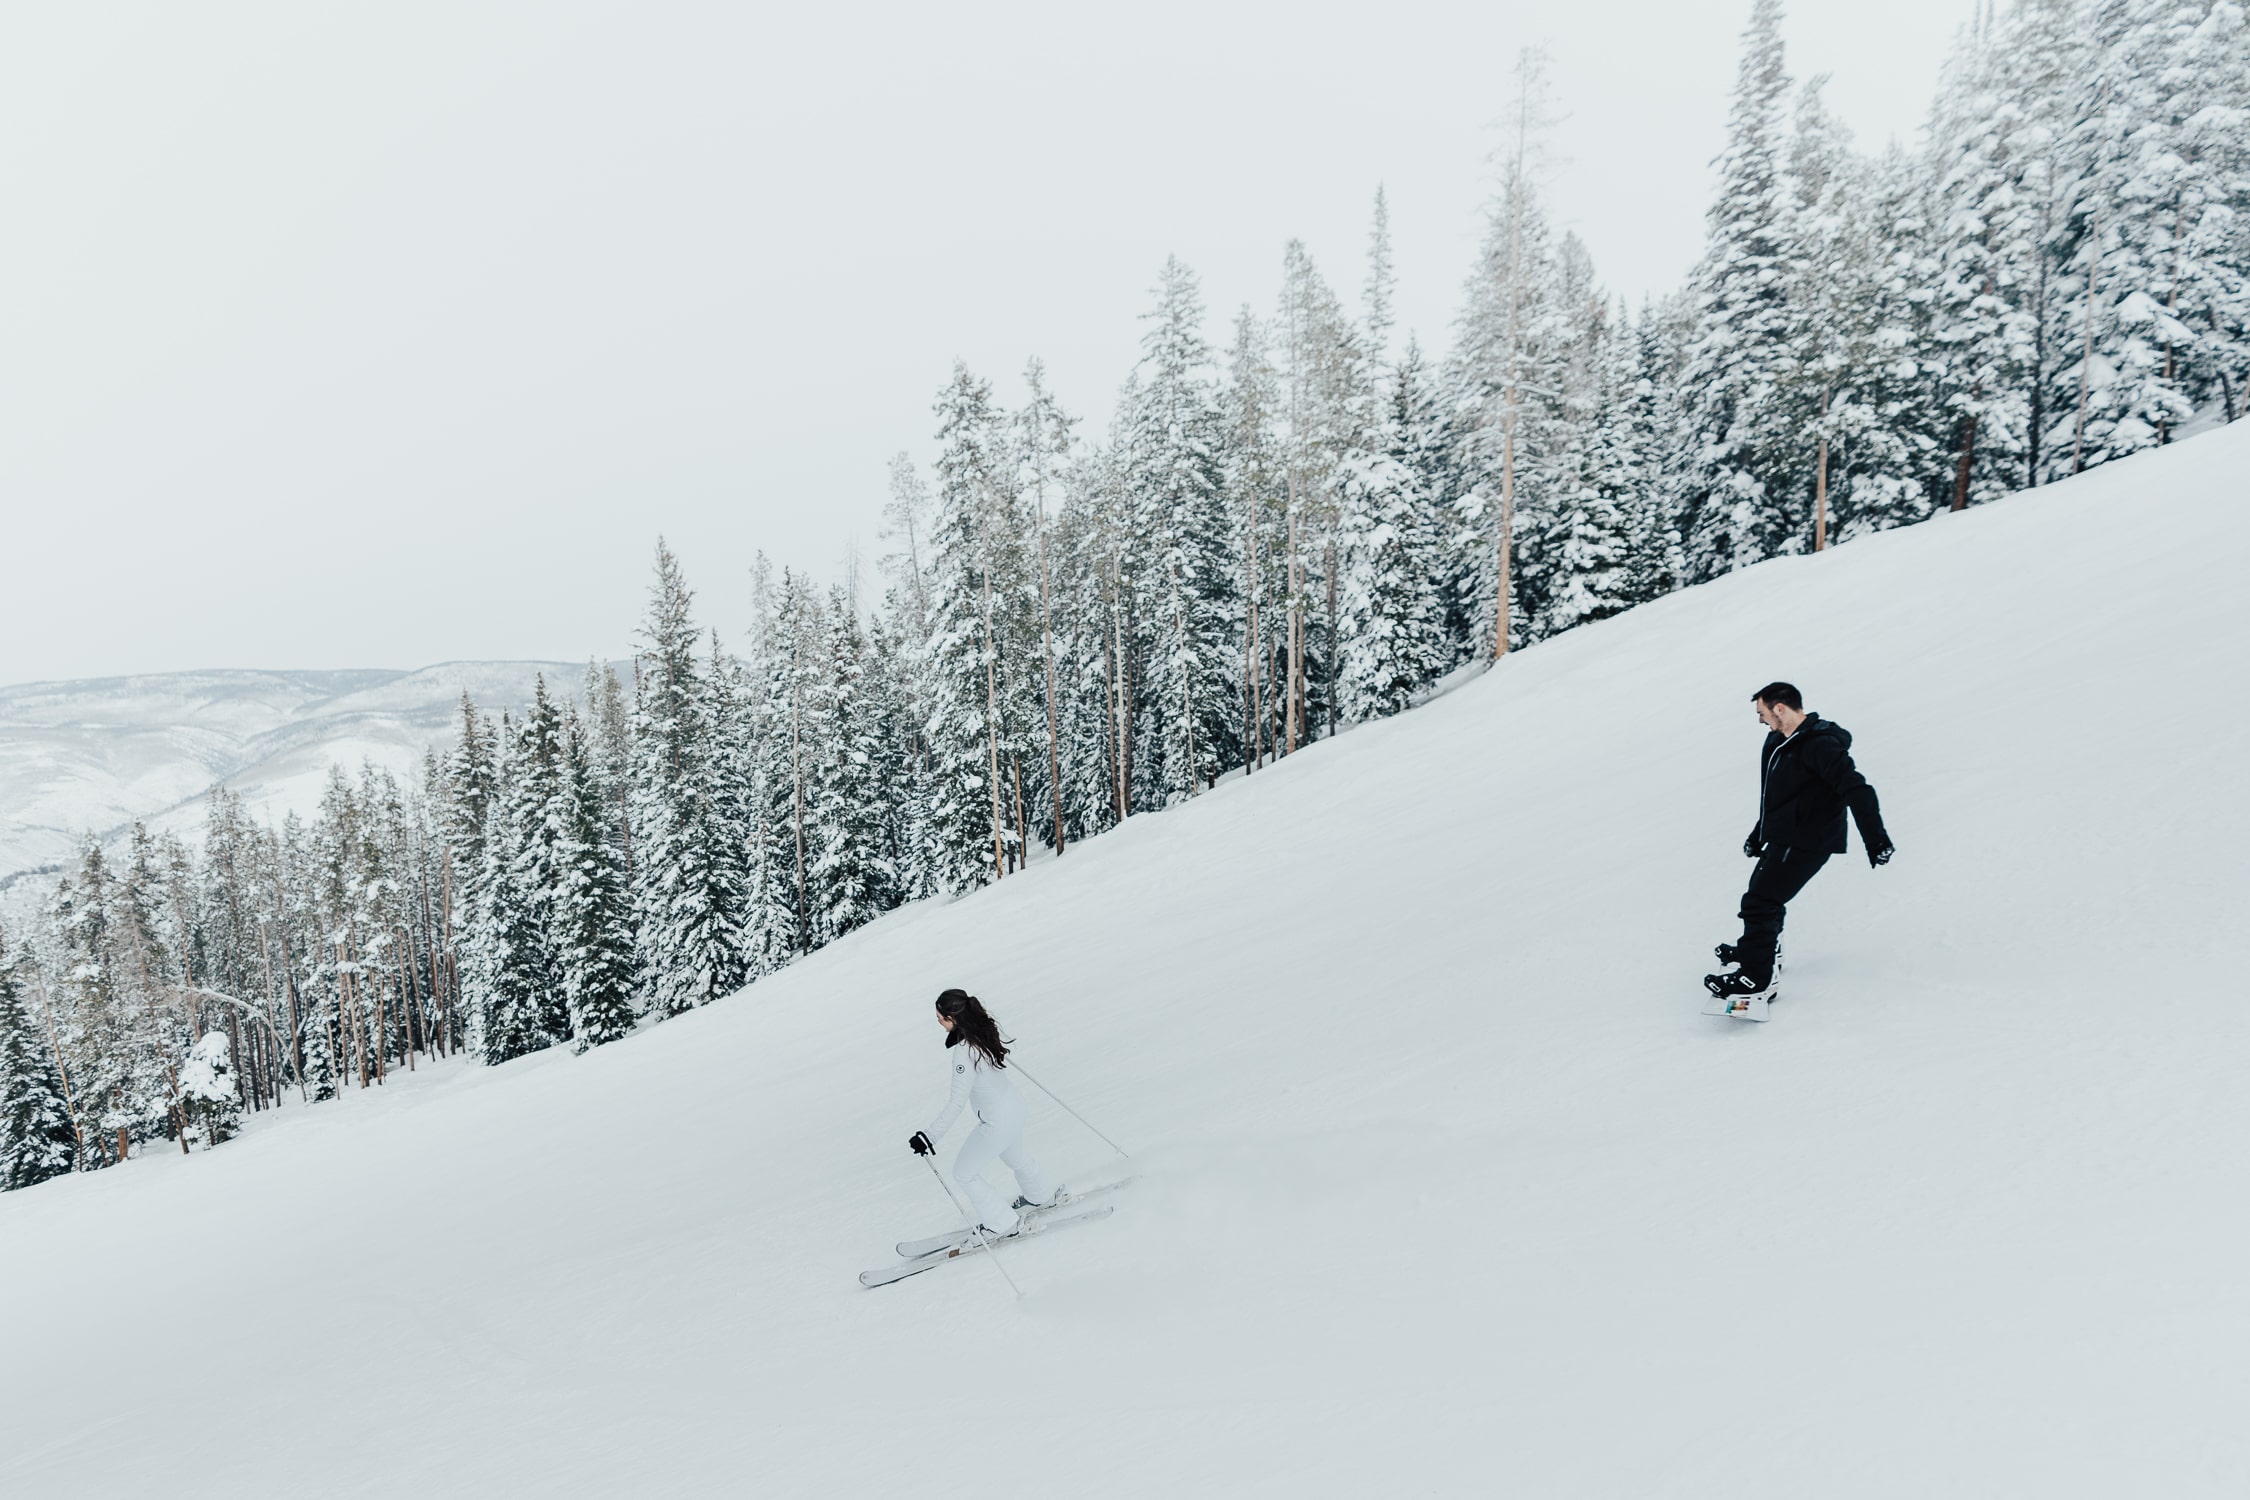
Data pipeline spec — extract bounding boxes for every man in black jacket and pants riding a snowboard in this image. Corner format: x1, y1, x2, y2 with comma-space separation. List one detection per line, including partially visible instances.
1703, 681, 1892, 999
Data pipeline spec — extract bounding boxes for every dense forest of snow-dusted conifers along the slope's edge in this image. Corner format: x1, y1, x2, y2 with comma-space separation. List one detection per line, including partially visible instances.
0, 0, 2250, 1187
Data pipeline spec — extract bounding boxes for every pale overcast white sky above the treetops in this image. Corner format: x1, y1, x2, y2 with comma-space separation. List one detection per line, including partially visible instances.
0, 0, 1969, 681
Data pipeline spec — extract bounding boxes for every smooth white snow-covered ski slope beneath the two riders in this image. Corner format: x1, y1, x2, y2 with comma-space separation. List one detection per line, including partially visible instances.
0, 423, 2250, 1500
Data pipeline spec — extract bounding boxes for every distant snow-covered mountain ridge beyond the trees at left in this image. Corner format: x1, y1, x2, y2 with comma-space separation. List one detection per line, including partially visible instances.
0, 661, 585, 886
